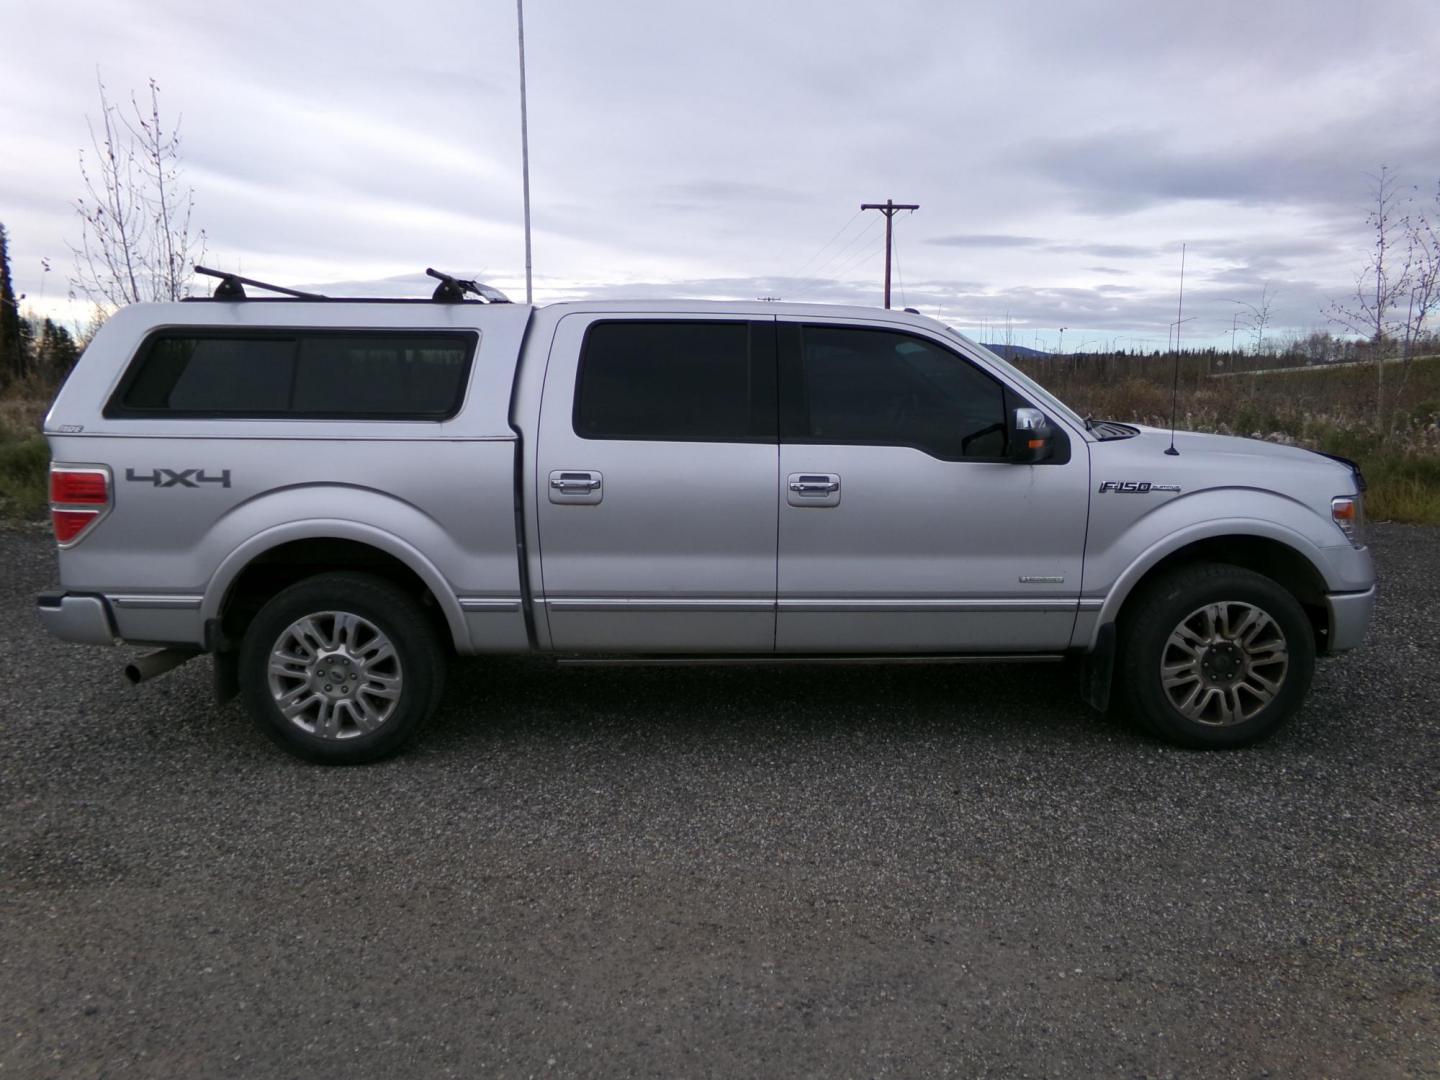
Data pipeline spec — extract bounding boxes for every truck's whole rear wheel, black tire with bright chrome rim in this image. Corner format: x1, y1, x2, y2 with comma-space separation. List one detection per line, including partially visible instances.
239, 573, 445, 765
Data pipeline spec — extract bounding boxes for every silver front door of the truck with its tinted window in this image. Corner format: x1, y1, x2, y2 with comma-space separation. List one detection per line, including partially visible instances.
776, 320, 1090, 652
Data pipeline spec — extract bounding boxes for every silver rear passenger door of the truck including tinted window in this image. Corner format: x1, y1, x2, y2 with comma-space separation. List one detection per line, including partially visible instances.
534, 314, 779, 654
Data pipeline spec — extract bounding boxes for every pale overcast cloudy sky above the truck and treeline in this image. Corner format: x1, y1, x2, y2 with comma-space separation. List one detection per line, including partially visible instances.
0, 0, 1440, 350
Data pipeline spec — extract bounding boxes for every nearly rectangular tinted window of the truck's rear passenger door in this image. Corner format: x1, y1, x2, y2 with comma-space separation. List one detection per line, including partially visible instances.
573, 321, 775, 442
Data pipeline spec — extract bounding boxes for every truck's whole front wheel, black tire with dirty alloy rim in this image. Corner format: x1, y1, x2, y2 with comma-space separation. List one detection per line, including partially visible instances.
1115, 563, 1315, 750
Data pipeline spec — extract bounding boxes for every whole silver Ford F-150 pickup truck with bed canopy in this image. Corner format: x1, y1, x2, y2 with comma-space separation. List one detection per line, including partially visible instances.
39, 282, 1375, 763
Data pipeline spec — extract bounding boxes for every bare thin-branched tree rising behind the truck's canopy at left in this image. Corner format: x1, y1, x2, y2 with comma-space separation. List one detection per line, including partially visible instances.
71, 76, 204, 307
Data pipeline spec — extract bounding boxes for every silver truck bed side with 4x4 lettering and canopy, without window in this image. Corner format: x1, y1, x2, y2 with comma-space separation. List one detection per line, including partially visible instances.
46, 302, 530, 651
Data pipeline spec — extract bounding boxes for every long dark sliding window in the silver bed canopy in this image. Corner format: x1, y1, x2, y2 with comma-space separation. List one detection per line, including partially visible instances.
105, 331, 475, 420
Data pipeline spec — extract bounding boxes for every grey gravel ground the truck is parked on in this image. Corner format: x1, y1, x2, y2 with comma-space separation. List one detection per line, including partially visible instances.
0, 526, 1440, 1077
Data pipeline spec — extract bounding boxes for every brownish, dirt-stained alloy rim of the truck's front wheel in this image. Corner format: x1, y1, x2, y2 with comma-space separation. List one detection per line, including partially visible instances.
1161, 600, 1290, 727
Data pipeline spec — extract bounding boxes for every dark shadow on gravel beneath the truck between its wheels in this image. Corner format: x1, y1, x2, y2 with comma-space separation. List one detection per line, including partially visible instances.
425, 658, 1130, 750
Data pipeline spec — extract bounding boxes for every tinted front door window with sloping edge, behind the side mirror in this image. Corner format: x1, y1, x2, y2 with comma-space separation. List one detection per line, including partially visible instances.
795, 325, 1008, 461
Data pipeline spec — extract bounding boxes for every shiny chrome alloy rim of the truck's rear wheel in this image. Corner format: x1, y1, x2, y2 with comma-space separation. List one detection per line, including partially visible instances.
269, 611, 403, 739
